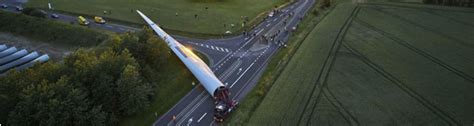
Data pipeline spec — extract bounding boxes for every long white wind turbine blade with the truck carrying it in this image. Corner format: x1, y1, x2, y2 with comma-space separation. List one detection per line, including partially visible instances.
137, 10, 238, 122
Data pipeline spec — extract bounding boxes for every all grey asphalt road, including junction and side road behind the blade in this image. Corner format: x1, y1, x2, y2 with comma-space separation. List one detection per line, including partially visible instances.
0, 0, 315, 126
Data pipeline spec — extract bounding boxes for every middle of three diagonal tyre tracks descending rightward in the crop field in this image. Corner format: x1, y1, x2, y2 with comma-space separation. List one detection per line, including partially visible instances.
355, 19, 474, 83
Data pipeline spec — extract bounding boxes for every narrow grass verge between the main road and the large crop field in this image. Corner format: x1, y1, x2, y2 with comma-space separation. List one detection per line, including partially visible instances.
227, 1, 334, 125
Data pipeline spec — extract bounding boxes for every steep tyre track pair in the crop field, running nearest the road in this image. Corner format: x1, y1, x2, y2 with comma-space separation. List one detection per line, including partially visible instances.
298, 5, 360, 125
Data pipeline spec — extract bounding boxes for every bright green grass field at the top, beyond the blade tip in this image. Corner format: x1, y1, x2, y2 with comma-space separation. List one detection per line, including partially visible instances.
27, 0, 287, 34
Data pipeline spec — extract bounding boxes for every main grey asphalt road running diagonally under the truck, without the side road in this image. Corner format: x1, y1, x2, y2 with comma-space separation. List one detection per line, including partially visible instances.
153, 0, 314, 126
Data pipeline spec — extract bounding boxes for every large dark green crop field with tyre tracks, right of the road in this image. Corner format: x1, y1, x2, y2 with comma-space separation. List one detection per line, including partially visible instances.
247, 3, 474, 125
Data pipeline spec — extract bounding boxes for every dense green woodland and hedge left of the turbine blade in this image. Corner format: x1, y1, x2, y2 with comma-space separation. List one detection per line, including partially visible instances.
0, 12, 184, 126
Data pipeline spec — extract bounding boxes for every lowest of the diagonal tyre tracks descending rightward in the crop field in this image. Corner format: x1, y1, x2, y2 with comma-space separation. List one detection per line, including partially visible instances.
343, 43, 461, 125
